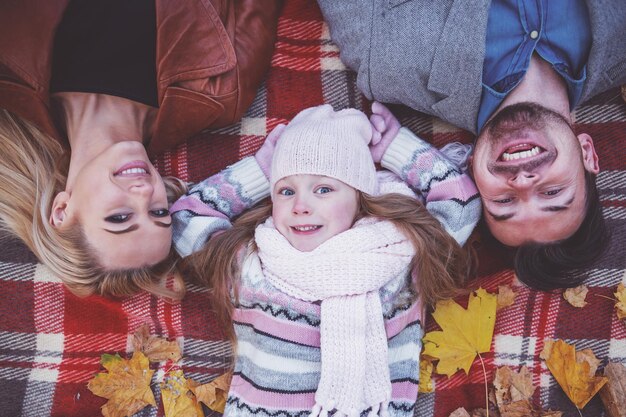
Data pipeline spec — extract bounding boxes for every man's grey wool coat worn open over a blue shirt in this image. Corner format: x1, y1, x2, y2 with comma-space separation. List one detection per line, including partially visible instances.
318, 0, 626, 133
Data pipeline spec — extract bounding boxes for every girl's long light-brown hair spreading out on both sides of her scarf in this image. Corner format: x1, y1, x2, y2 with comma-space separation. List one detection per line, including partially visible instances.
183, 193, 472, 343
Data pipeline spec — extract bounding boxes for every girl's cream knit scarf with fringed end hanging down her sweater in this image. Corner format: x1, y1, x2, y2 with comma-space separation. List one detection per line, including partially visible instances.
255, 218, 415, 416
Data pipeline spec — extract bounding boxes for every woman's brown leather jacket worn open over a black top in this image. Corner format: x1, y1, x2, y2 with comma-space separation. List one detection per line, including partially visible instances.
0, 0, 282, 153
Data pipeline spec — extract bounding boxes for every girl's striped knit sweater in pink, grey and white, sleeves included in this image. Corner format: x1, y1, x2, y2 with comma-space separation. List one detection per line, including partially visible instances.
172, 129, 480, 417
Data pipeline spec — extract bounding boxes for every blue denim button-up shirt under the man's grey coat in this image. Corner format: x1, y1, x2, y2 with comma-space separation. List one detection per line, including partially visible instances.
477, 0, 591, 132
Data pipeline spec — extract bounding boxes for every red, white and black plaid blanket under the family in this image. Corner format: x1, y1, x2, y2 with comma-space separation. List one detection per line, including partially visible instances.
0, 0, 626, 417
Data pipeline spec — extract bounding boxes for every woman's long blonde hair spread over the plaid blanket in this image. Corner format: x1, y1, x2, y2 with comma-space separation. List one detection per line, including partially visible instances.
0, 109, 185, 300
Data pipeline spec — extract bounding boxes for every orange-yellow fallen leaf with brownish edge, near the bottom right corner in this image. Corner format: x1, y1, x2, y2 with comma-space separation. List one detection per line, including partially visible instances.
540, 340, 607, 409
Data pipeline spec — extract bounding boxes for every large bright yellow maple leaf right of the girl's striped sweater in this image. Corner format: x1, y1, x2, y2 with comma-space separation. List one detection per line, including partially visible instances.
424, 288, 497, 376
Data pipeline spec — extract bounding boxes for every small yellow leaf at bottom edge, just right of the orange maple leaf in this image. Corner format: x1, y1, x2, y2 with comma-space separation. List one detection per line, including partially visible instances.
161, 370, 204, 417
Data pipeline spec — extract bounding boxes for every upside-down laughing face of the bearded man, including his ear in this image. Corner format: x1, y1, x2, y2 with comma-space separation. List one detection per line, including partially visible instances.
472, 103, 599, 246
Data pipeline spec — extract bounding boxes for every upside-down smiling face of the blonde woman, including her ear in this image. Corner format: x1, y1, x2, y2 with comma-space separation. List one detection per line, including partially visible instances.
50, 141, 172, 269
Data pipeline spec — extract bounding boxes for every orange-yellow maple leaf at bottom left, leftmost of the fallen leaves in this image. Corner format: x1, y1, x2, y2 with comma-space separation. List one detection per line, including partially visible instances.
87, 352, 156, 417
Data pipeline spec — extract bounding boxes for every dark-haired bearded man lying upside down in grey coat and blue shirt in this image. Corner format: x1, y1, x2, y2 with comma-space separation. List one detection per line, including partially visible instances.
319, 0, 626, 288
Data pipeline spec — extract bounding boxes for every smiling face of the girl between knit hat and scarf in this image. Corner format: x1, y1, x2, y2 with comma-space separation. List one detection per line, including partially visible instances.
272, 174, 359, 252
